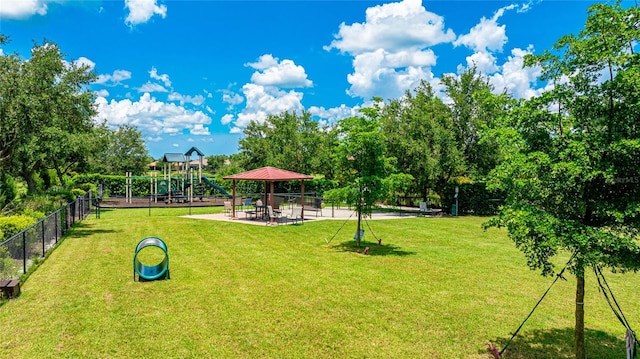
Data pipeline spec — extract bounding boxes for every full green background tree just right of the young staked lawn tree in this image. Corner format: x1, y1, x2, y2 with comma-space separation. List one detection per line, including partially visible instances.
382, 82, 464, 205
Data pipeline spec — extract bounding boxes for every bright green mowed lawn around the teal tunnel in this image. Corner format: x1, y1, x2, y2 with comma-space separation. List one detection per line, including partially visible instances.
0, 209, 640, 358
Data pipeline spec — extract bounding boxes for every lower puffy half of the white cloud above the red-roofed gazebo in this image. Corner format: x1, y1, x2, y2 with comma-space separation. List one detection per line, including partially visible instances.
222, 83, 304, 133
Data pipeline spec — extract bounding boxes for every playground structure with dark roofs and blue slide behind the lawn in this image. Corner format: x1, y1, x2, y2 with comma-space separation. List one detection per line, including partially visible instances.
125, 147, 231, 204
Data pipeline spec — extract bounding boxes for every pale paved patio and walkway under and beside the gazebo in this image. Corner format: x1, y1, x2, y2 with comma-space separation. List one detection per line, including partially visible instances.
182, 208, 430, 226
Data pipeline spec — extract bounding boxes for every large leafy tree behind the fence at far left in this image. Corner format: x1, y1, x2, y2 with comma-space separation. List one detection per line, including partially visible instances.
0, 37, 95, 192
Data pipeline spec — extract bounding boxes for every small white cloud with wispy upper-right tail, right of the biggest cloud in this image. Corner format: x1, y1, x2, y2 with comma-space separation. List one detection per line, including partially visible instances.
453, 5, 515, 51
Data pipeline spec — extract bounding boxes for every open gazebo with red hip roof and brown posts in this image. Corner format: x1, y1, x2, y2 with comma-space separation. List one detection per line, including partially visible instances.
223, 166, 313, 218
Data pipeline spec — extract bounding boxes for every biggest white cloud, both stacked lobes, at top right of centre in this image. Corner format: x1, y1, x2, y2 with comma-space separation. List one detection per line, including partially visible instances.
325, 0, 455, 100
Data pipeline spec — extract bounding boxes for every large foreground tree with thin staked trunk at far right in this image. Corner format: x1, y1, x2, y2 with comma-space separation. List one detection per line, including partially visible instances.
489, 3, 640, 359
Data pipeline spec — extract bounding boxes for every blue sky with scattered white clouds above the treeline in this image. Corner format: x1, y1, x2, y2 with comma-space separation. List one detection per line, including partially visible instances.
0, 0, 608, 158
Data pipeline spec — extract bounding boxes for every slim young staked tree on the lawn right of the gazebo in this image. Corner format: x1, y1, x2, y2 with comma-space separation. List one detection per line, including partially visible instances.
328, 99, 392, 247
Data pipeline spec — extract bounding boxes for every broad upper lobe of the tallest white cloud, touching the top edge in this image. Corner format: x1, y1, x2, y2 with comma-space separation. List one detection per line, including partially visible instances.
325, 0, 455, 55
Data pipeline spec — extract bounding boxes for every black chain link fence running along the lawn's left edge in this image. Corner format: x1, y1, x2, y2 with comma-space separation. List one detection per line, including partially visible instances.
0, 192, 93, 280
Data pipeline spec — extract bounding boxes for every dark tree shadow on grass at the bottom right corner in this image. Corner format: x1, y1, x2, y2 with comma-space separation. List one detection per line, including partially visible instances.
479, 328, 625, 359
